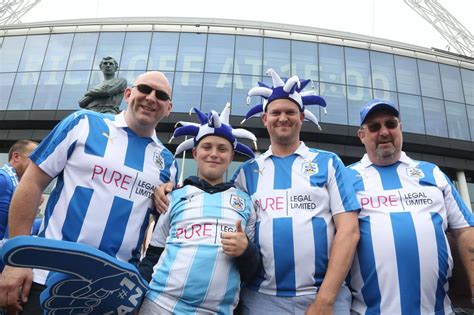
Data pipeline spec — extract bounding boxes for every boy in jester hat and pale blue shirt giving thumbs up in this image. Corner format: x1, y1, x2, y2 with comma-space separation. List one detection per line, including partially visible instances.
140, 104, 260, 314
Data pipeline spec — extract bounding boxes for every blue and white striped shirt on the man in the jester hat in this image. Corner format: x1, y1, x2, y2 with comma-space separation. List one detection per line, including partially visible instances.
234, 142, 359, 296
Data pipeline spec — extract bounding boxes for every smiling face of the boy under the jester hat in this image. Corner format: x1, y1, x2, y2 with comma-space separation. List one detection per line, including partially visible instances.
193, 136, 234, 185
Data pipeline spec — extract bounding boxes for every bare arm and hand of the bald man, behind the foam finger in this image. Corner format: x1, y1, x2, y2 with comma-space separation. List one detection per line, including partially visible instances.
0, 163, 52, 311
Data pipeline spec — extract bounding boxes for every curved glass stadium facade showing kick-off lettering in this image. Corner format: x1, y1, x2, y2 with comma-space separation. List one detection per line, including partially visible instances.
0, 26, 474, 141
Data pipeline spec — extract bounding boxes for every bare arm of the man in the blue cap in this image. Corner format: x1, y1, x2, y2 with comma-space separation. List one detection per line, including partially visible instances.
451, 227, 474, 303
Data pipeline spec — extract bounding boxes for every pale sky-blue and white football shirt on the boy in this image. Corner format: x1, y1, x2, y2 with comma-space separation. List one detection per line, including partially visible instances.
146, 185, 255, 314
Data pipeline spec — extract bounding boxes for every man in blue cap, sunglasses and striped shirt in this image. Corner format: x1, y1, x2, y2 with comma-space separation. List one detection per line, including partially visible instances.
348, 100, 474, 314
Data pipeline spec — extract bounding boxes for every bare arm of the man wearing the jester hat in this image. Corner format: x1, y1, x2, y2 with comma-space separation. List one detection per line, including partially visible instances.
306, 211, 359, 314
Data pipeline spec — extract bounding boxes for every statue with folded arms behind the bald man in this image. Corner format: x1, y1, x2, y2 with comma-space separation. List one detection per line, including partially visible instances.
79, 56, 127, 114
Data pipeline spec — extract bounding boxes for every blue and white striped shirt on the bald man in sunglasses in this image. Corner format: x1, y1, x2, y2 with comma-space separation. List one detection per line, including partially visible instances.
30, 110, 177, 283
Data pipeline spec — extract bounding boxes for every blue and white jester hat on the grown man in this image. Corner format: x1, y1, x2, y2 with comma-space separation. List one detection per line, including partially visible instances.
242, 69, 326, 130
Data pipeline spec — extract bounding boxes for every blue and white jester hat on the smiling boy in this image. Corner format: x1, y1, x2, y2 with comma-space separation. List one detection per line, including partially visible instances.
170, 103, 257, 158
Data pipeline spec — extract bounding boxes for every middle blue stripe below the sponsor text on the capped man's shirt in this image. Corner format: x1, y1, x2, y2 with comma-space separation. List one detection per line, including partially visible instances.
390, 212, 421, 315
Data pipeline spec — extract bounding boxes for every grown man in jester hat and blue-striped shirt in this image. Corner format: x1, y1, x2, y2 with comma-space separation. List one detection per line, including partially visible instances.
234, 69, 359, 315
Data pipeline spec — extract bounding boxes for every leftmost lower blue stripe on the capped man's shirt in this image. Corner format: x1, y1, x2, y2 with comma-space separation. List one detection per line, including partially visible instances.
357, 216, 382, 314
